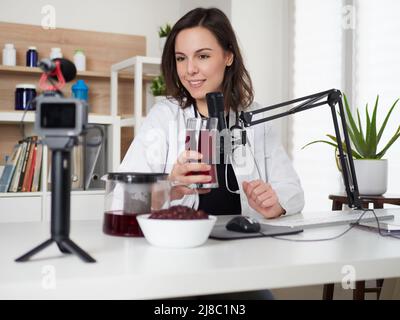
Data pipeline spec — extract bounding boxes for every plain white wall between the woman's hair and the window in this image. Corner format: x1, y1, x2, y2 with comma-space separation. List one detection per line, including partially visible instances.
231, 0, 289, 145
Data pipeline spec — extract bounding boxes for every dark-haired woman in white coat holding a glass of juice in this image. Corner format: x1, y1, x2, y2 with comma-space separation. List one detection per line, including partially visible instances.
120, 8, 304, 218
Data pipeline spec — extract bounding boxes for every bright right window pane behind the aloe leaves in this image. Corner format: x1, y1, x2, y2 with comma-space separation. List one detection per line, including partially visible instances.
353, 0, 400, 198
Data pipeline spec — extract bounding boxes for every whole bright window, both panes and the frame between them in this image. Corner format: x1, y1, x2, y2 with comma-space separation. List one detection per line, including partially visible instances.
288, 0, 400, 211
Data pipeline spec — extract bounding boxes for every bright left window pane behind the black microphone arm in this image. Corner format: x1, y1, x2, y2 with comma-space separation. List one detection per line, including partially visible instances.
288, 0, 343, 211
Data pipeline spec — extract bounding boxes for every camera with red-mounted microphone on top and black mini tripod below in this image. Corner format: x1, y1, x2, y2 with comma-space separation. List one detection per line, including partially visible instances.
16, 59, 96, 262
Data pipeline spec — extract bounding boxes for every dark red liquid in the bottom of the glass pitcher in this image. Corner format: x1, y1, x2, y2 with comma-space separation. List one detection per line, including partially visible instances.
103, 211, 143, 237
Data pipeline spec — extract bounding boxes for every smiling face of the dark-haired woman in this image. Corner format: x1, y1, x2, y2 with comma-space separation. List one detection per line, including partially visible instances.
175, 27, 233, 101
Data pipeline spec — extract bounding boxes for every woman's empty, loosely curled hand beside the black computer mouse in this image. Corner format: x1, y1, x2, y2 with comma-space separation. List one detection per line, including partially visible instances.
243, 180, 285, 218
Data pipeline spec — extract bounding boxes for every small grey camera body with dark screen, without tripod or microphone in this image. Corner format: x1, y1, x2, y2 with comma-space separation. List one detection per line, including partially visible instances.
35, 93, 88, 137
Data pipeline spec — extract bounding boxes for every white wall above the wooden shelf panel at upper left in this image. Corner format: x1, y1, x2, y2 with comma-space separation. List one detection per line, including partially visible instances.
0, 0, 181, 56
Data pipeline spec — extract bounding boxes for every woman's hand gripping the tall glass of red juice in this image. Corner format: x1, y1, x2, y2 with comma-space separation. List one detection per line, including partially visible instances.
169, 150, 211, 200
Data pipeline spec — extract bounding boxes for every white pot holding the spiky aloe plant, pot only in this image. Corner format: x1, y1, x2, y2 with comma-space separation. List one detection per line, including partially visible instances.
354, 159, 388, 195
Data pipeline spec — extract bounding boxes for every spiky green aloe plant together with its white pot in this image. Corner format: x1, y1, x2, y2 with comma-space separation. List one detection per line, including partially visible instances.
302, 95, 400, 195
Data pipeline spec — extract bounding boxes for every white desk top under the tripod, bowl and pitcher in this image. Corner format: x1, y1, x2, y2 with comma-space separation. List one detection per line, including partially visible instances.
0, 209, 400, 299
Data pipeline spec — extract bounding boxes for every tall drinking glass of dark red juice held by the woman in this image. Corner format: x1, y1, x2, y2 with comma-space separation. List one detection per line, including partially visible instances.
185, 118, 218, 189
